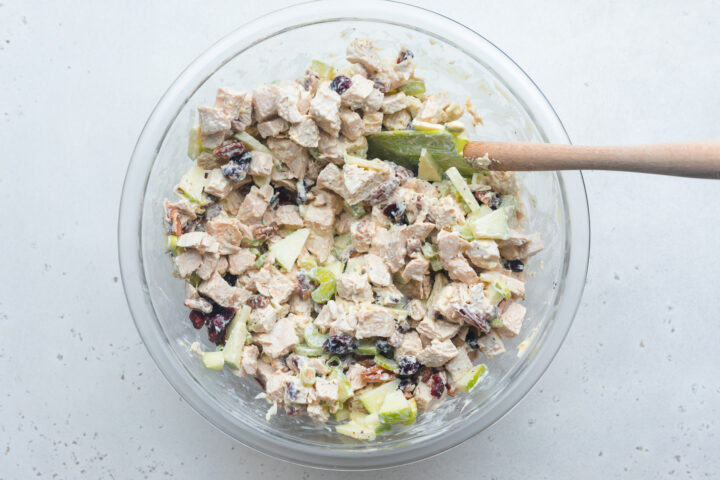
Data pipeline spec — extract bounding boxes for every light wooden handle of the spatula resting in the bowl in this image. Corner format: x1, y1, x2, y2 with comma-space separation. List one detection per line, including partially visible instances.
463, 142, 720, 179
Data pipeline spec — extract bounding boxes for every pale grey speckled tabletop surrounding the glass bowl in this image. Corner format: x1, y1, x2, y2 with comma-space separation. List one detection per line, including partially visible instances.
0, 0, 720, 479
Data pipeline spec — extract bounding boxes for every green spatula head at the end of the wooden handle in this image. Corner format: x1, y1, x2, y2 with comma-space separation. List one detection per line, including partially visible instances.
367, 129, 473, 175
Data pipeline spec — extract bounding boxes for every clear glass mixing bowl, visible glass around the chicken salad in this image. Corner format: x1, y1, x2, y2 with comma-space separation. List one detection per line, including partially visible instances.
119, 1, 589, 469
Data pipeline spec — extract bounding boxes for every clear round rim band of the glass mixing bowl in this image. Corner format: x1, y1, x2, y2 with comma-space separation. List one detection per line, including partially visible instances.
118, 0, 590, 470
